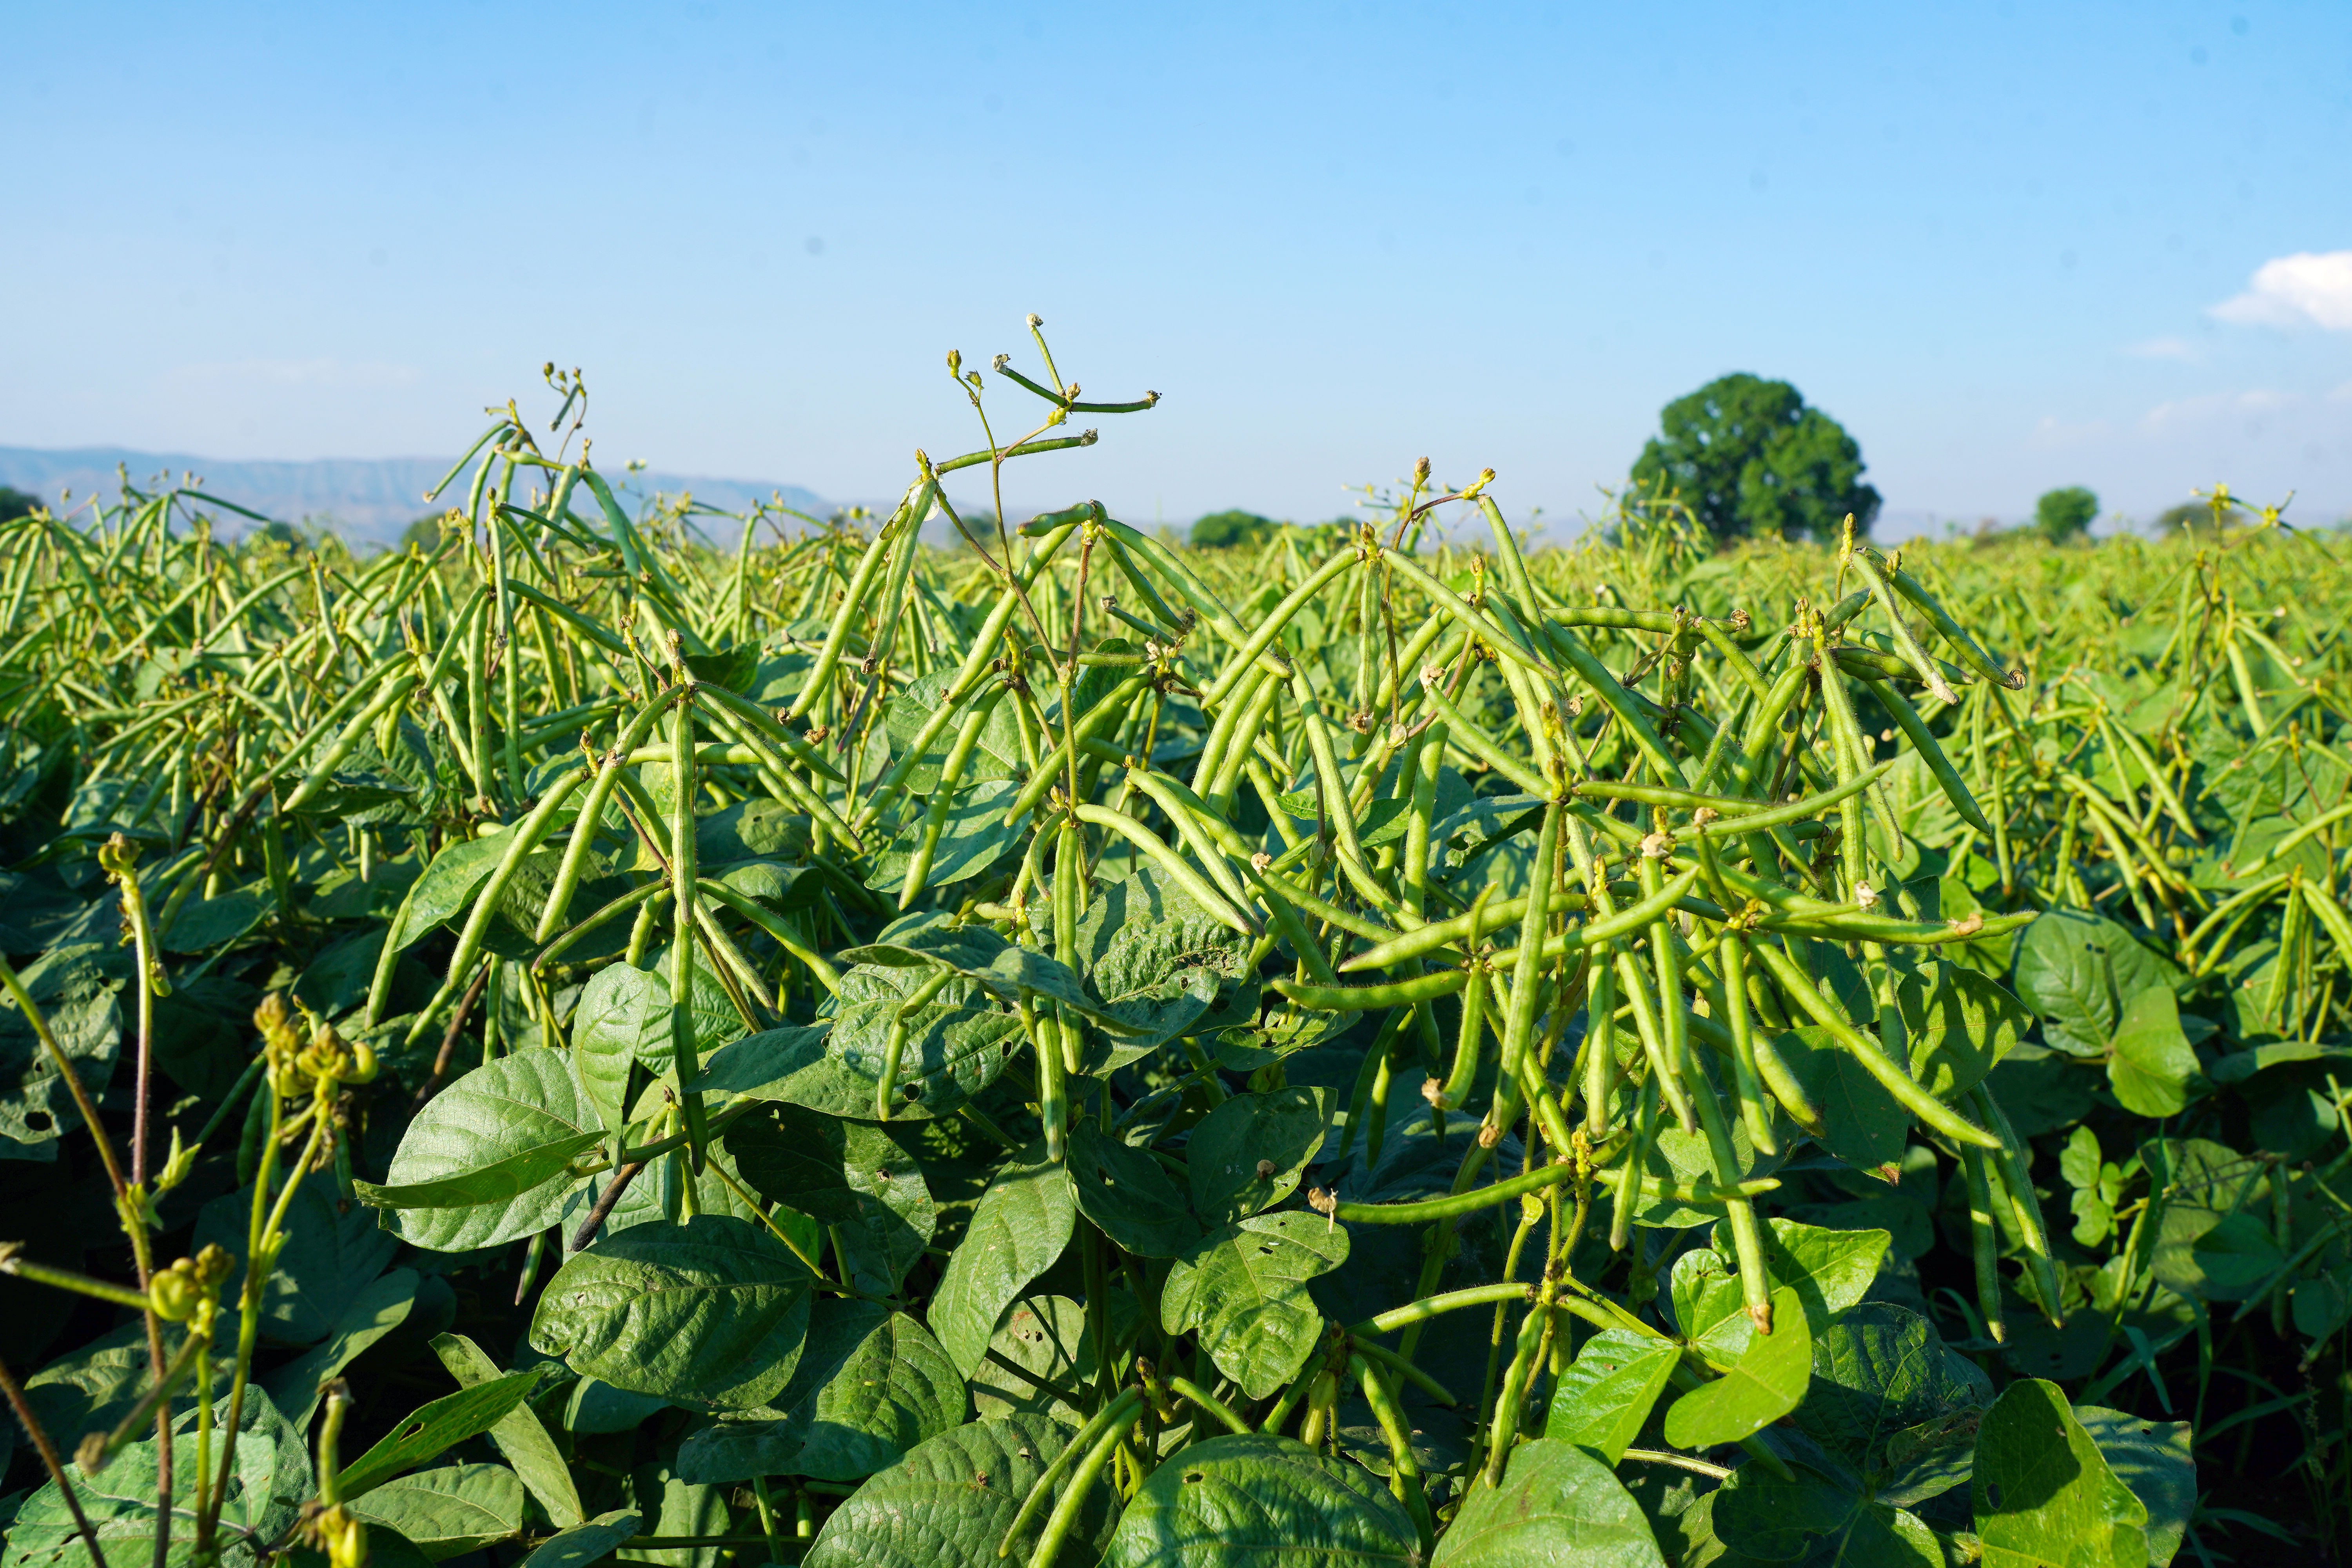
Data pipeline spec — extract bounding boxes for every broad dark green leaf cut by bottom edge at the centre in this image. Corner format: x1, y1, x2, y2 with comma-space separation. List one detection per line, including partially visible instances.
1103, 1432, 1411, 1568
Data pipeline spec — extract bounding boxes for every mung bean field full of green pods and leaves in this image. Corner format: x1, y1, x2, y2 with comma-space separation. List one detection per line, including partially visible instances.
0, 339, 2352, 1568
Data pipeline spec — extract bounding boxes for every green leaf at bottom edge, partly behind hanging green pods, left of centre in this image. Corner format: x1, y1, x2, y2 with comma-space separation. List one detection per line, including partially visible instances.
802, 1415, 1115, 1568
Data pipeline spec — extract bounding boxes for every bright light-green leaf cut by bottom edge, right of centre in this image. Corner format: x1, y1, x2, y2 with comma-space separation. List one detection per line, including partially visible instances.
1432, 1439, 1665, 1568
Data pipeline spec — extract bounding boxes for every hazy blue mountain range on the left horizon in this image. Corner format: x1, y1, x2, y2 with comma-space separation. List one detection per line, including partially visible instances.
0, 446, 833, 543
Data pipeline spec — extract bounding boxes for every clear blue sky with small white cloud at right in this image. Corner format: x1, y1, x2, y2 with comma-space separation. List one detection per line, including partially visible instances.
0, 0, 2352, 541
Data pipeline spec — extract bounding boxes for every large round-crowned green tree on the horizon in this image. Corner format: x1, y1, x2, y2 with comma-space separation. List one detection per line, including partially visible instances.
1632, 374, 1879, 541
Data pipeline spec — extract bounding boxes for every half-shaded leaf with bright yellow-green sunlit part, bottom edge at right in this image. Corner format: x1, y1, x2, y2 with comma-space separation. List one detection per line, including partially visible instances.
1971, 1377, 2147, 1568
